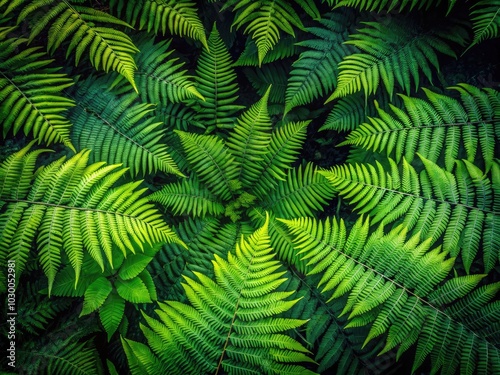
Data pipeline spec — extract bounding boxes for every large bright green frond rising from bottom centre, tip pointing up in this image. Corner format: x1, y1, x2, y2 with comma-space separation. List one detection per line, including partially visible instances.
122, 216, 313, 374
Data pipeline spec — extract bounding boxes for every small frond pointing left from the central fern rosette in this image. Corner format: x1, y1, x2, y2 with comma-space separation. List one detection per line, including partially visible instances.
149, 176, 224, 217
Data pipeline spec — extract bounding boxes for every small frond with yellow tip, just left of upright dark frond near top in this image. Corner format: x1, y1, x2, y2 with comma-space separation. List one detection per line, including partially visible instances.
135, 36, 204, 106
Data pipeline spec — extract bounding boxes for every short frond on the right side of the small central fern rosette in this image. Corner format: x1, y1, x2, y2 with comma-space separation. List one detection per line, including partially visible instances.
262, 163, 333, 218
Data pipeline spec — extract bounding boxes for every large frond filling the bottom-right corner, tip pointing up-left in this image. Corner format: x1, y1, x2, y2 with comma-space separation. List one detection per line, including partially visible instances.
284, 218, 500, 374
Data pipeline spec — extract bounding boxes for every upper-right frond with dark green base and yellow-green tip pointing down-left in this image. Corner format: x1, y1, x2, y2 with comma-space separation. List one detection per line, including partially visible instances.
327, 19, 464, 102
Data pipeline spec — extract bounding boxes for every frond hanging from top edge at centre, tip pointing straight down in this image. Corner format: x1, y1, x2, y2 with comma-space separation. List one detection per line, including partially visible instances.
223, 0, 320, 66
